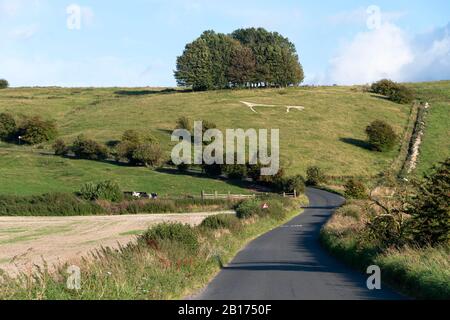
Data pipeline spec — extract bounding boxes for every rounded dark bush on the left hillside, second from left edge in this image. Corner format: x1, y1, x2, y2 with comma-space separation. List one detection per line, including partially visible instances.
18, 116, 58, 145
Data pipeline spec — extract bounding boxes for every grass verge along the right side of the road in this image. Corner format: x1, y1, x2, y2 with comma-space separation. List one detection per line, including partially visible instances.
321, 203, 450, 300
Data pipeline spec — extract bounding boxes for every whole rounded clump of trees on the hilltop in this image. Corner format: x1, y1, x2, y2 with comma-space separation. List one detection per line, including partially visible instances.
175, 28, 304, 91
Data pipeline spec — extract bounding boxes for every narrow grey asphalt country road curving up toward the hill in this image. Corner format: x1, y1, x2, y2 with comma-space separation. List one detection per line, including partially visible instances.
196, 189, 402, 300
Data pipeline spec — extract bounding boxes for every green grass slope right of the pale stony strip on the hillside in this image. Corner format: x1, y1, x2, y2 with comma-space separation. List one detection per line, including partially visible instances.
409, 81, 450, 175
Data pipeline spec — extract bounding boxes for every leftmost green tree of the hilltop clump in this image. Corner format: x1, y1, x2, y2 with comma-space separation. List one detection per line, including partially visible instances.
175, 39, 213, 91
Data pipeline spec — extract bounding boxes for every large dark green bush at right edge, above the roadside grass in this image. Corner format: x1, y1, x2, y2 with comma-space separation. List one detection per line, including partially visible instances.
408, 158, 450, 246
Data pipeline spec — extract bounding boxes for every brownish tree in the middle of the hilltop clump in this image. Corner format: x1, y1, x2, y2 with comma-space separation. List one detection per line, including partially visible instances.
227, 45, 256, 87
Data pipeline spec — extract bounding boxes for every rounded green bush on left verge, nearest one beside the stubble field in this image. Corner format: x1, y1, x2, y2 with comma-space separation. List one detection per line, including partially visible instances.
139, 223, 199, 252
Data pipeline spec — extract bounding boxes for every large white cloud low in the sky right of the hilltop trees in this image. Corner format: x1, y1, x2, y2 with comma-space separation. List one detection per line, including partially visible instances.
322, 23, 450, 85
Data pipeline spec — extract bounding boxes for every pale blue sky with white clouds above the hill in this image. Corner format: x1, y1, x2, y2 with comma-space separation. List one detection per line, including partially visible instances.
0, 0, 450, 87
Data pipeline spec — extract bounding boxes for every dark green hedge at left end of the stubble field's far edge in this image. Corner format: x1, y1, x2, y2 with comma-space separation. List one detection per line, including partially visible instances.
0, 193, 105, 216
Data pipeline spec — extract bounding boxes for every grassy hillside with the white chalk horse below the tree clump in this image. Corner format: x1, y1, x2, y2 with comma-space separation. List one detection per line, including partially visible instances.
0, 82, 450, 194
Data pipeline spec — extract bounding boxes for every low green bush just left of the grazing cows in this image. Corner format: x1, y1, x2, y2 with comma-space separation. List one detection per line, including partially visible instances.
78, 181, 123, 202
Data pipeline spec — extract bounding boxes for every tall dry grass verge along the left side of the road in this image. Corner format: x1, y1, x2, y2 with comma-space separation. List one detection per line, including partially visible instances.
0, 197, 306, 300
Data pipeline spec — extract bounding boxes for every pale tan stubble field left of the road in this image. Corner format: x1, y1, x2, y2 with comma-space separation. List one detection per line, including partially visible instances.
0, 213, 232, 274
